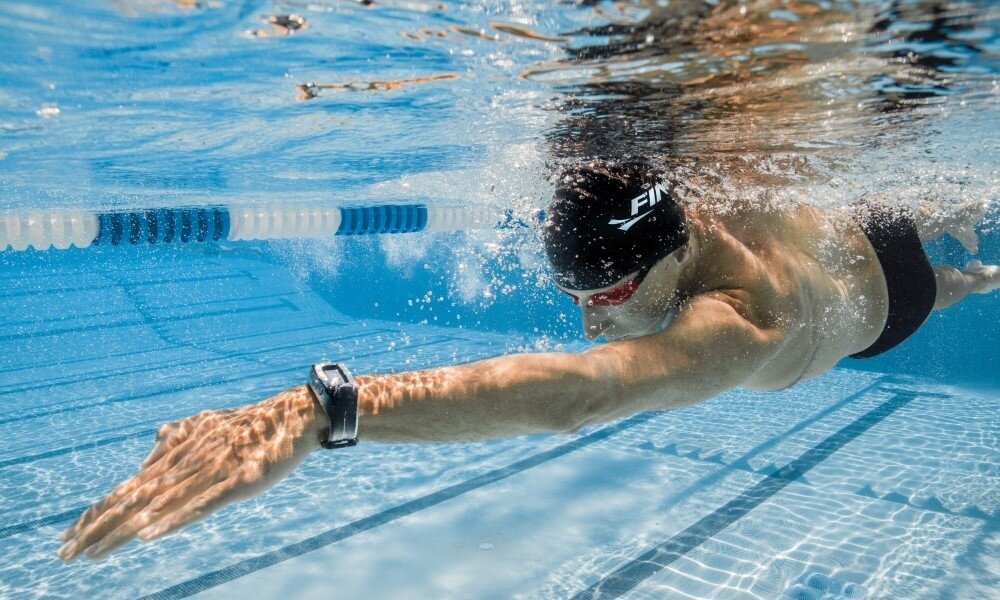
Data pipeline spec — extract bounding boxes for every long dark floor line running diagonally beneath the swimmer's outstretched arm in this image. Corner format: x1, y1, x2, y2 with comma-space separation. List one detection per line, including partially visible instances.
139, 412, 662, 600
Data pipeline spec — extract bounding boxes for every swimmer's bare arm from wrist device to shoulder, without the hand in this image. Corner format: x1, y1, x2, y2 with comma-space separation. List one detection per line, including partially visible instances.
358, 296, 782, 442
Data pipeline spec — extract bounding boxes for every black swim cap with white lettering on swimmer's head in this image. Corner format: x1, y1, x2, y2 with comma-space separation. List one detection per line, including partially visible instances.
542, 163, 690, 290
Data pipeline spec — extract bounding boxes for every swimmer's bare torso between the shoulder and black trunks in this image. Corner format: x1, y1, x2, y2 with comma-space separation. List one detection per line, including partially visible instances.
689, 204, 887, 389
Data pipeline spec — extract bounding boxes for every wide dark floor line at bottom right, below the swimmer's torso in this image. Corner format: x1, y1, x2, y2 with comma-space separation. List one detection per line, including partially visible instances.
573, 392, 917, 600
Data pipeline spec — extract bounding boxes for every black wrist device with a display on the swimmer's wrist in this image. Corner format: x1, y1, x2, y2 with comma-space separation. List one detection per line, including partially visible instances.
309, 362, 358, 450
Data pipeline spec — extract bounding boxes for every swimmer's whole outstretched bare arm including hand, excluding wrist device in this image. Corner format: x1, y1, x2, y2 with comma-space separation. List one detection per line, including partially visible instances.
59, 295, 783, 561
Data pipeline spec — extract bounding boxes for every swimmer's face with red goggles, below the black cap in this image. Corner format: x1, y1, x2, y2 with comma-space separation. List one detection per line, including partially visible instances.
557, 248, 686, 342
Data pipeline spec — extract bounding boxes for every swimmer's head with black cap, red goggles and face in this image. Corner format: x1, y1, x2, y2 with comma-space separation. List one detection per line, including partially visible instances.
542, 163, 690, 340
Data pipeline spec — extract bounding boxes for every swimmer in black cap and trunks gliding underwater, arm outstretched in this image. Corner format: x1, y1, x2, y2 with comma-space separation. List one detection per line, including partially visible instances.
59, 163, 1000, 561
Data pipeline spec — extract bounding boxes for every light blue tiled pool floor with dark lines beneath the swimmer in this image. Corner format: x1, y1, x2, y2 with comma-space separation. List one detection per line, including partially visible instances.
0, 247, 1000, 599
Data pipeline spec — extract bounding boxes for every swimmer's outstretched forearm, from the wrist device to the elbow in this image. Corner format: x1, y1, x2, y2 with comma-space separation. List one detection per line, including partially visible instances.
358, 353, 616, 442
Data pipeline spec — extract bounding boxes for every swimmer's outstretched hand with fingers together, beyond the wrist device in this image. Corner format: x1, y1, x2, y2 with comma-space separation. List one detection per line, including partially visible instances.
59, 386, 330, 561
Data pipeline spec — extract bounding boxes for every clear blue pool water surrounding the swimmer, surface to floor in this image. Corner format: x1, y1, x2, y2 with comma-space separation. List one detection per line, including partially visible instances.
0, 0, 1000, 599
